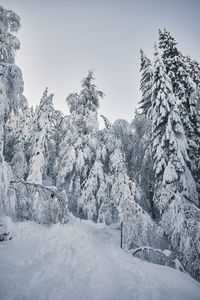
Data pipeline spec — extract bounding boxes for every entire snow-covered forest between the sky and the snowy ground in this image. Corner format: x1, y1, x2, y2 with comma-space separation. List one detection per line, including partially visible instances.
0, 7, 200, 300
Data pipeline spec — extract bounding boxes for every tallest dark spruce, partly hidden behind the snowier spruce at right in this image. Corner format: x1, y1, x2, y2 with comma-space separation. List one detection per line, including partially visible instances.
159, 29, 200, 197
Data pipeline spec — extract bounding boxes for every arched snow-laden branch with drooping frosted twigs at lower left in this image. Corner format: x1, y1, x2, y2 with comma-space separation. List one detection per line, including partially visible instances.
10, 180, 69, 224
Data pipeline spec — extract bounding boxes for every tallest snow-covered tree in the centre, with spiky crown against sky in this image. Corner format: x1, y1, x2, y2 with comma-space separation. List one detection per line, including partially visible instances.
57, 72, 103, 219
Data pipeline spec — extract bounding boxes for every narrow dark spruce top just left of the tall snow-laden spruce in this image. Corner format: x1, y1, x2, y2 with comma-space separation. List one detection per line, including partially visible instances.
139, 49, 153, 116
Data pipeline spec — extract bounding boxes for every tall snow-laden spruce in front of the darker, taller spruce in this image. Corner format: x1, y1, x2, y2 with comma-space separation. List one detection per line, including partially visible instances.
151, 45, 198, 214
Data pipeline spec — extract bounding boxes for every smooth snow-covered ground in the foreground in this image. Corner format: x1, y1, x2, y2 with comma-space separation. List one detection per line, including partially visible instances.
0, 219, 200, 300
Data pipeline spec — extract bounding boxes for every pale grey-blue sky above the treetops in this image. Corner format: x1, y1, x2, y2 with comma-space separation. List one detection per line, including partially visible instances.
1, 0, 200, 121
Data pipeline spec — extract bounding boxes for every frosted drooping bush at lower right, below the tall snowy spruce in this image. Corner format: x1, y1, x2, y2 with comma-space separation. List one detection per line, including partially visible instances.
161, 191, 200, 280
